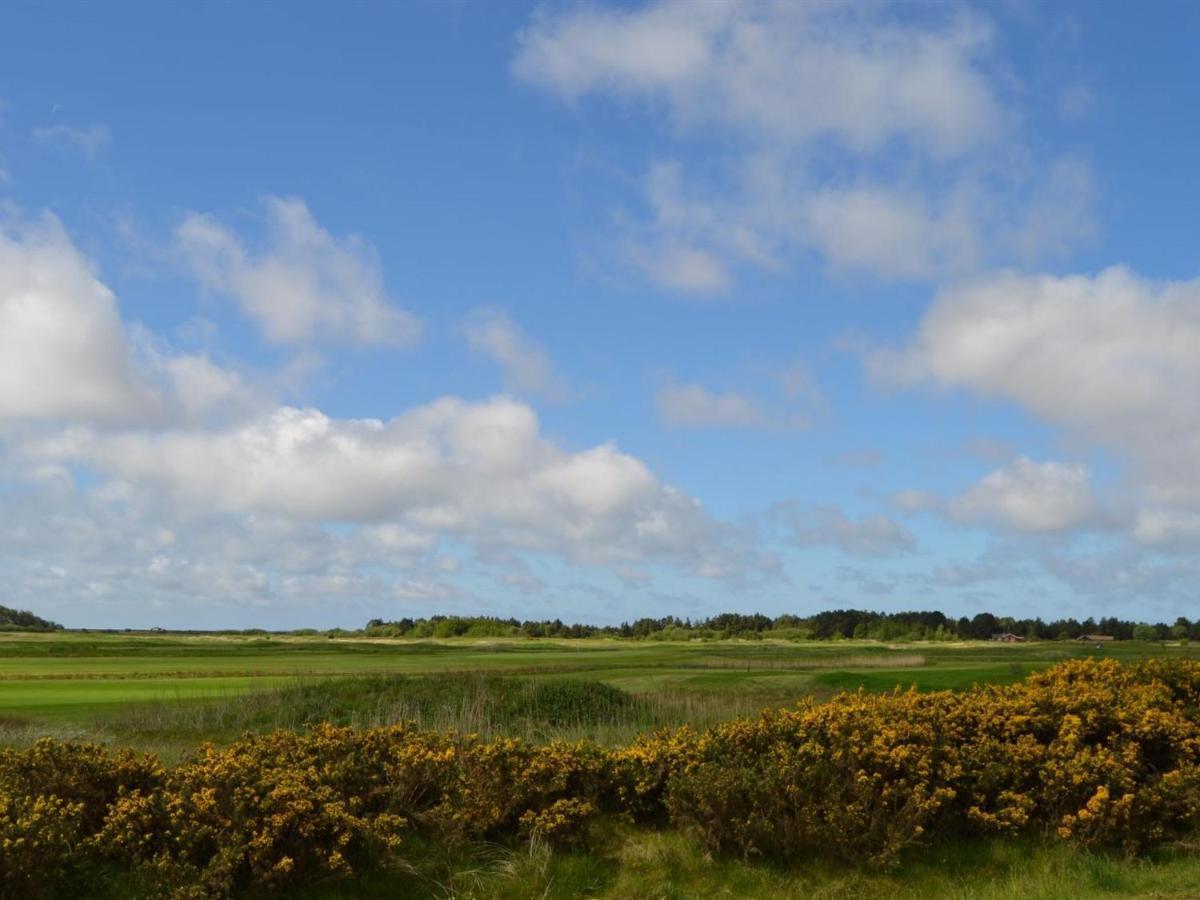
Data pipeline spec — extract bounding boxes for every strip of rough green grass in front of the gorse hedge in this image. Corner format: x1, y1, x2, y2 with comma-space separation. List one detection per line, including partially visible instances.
285, 828, 1200, 900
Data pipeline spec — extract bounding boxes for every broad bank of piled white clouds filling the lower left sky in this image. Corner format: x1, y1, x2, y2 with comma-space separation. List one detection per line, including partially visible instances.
0, 204, 770, 624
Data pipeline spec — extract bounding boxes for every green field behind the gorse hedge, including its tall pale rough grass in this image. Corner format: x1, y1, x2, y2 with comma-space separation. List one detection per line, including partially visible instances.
0, 632, 1200, 756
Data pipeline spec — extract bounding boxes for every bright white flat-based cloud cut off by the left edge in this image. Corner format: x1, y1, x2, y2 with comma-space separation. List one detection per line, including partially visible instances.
0, 215, 161, 422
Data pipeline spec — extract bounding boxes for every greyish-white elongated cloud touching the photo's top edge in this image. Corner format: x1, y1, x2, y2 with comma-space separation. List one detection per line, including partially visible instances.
514, 0, 1001, 155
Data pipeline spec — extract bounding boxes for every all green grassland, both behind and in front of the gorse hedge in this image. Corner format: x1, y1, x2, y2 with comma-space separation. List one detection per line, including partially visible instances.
0, 632, 1200, 898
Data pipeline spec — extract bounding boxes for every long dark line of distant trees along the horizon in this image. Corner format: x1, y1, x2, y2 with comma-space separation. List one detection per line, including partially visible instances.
364, 610, 1200, 641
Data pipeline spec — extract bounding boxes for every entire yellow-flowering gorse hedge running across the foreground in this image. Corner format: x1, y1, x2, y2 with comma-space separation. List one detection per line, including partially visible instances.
0, 660, 1200, 896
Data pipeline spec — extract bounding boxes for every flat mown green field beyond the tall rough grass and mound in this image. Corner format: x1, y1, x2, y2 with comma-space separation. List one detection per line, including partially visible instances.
0, 632, 1200, 739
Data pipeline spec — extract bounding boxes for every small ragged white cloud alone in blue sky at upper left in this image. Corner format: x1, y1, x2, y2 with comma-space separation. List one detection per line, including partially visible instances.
175, 197, 421, 346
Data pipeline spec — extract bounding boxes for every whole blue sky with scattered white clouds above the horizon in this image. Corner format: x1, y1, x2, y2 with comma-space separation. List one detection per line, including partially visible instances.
0, 0, 1200, 629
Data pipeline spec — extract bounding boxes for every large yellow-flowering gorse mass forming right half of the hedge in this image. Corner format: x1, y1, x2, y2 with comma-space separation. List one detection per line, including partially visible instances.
666, 660, 1200, 863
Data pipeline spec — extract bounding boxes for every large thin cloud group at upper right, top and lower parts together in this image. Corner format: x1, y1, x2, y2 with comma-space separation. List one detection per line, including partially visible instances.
514, 0, 1096, 294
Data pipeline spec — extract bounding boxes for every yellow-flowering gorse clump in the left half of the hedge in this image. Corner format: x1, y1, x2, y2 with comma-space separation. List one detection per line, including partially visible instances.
95, 725, 604, 895
